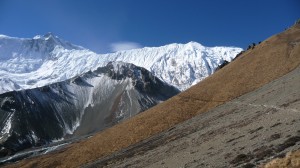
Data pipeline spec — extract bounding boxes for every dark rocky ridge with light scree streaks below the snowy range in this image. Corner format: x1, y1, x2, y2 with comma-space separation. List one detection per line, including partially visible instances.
0, 62, 179, 159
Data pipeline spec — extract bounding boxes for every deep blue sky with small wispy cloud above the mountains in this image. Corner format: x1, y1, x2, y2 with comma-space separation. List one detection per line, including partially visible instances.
0, 0, 300, 53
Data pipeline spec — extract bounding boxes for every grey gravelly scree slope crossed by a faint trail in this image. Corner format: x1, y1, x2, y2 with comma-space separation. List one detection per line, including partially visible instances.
86, 61, 300, 168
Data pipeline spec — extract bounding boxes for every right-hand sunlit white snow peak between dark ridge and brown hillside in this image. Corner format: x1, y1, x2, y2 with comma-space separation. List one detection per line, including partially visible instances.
102, 42, 242, 90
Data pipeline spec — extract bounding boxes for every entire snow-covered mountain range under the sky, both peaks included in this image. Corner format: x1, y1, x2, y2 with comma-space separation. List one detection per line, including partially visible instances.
0, 33, 241, 93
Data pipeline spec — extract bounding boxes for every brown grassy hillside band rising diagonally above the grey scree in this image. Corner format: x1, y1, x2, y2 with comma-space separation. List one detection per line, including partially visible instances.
9, 25, 300, 167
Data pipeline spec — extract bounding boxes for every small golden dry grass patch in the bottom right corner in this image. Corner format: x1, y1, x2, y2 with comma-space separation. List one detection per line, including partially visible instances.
263, 150, 300, 168
